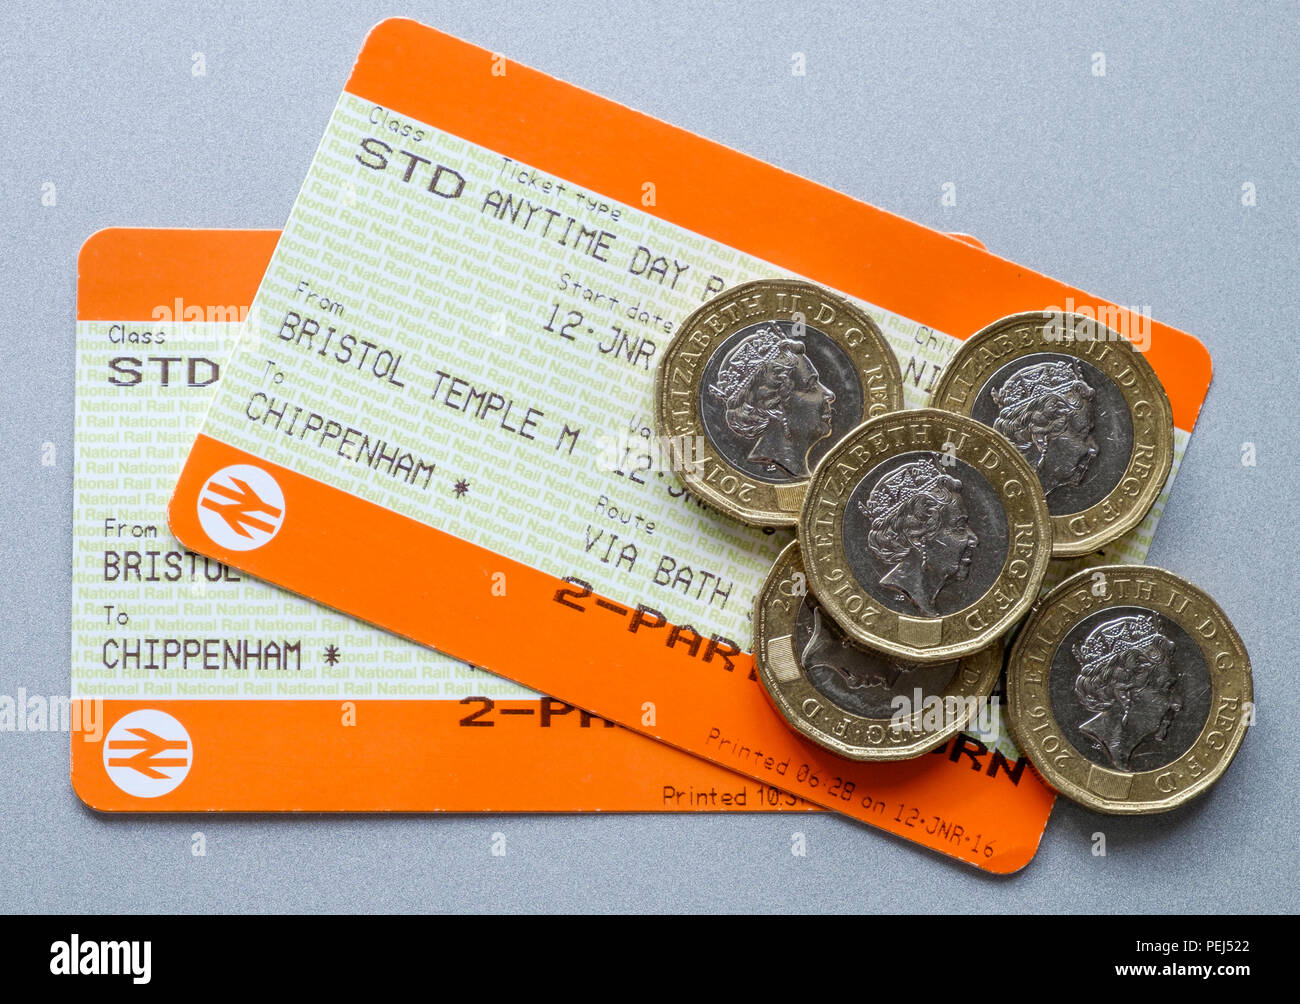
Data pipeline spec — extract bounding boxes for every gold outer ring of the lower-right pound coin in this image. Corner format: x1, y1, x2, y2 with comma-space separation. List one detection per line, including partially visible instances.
1006, 564, 1253, 815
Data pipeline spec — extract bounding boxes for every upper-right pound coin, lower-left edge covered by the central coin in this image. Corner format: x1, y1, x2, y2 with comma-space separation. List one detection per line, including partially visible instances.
930, 311, 1174, 558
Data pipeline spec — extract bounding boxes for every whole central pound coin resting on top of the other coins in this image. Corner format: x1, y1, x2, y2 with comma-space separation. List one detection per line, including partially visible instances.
798, 408, 1052, 662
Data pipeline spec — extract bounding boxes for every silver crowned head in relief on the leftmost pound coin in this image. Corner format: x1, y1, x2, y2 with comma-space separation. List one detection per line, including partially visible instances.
709, 325, 835, 480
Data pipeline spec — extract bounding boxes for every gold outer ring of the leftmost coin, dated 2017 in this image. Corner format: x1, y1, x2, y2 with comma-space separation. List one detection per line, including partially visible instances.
655, 278, 902, 527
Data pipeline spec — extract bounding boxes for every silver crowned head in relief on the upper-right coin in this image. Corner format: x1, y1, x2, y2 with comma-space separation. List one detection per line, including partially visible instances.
992, 360, 1097, 497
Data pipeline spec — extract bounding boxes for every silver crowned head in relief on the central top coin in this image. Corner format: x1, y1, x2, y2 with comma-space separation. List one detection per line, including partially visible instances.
857, 456, 979, 616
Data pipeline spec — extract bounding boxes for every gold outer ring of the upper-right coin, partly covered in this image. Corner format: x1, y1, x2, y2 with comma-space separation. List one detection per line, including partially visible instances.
930, 311, 1174, 558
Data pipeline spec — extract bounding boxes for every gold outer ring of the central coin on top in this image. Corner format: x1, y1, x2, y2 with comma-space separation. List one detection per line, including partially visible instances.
798, 408, 1052, 662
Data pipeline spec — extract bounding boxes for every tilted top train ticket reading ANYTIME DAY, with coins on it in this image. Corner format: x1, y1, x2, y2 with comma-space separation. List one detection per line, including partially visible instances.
169, 20, 1209, 871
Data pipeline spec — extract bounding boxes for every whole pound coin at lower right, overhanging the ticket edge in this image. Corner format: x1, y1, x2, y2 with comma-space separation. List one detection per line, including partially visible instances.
1006, 564, 1253, 814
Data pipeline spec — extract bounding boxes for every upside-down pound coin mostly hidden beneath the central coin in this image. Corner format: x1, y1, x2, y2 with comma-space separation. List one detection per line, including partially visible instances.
754, 544, 1002, 761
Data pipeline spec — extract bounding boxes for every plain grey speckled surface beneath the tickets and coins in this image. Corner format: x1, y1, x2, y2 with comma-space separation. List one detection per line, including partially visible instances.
0, 0, 1300, 913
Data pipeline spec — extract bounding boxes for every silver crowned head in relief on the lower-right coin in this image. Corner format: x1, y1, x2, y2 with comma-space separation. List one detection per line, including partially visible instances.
1073, 614, 1183, 770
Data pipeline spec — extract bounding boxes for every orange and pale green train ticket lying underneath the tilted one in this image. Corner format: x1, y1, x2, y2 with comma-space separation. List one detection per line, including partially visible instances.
72, 229, 811, 812
